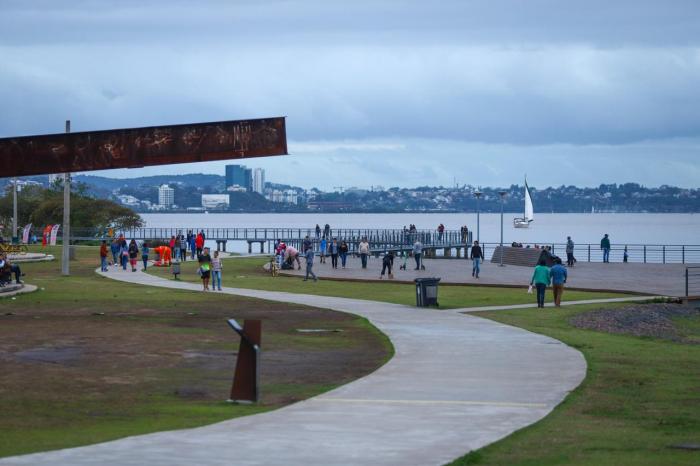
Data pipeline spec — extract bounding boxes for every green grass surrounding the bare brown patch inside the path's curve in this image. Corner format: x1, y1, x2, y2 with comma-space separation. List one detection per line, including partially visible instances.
0, 248, 393, 457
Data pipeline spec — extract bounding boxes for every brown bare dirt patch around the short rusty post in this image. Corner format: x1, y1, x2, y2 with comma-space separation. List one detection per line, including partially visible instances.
0, 301, 387, 408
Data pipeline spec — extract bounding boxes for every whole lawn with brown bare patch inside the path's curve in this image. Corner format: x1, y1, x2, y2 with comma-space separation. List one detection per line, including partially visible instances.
0, 247, 393, 457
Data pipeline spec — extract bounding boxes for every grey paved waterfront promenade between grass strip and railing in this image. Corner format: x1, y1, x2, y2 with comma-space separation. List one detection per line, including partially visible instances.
282, 257, 687, 300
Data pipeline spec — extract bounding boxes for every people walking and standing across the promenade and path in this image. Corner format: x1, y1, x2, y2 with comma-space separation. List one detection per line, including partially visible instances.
89, 223, 628, 307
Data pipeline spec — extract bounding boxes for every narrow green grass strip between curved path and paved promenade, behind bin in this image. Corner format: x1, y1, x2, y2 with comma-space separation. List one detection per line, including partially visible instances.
149, 257, 625, 309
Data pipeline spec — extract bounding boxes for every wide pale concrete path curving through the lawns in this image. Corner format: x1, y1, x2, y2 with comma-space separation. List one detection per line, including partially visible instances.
0, 268, 586, 466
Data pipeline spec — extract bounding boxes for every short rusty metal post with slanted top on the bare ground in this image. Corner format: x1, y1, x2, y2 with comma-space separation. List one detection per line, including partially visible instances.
228, 319, 262, 403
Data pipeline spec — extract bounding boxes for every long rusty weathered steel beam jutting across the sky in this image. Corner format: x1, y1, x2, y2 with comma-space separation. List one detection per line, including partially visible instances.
0, 117, 287, 177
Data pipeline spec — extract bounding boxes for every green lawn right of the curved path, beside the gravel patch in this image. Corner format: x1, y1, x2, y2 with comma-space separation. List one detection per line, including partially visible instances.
452, 306, 700, 466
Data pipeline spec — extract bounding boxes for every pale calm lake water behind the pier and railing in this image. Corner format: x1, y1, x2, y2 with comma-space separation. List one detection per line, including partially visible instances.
142, 213, 700, 251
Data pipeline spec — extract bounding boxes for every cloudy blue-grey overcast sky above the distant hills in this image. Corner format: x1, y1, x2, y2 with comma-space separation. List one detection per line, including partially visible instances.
0, 0, 700, 188
